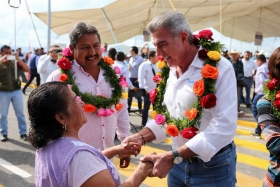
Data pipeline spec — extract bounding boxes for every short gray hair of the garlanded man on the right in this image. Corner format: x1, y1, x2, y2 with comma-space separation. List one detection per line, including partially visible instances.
146, 11, 193, 44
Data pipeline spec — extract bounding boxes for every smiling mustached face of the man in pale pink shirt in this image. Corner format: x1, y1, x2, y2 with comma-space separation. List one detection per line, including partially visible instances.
70, 33, 102, 69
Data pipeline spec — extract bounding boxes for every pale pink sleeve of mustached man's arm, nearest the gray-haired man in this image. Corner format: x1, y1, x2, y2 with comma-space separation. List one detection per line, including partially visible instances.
116, 99, 130, 141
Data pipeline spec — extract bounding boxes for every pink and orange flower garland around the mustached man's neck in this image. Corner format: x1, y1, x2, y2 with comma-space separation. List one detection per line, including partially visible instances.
57, 48, 128, 117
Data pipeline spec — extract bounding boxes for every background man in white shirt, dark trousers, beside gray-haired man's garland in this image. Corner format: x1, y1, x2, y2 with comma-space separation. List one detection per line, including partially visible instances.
138, 51, 159, 127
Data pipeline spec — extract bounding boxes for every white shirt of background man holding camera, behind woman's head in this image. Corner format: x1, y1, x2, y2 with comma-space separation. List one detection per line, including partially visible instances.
37, 55, 58, 84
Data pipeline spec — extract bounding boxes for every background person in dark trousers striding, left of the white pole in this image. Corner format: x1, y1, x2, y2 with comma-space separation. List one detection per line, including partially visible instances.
22, 48, 41, 95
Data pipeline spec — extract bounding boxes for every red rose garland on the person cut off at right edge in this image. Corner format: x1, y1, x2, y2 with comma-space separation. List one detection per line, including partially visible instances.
264, 76, 280, 119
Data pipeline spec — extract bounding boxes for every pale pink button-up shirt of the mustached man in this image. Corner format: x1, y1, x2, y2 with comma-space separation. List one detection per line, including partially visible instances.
47, 61, 130, 150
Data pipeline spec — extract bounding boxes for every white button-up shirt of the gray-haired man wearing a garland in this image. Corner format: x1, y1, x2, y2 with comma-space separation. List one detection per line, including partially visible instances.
146, 55, 237, 162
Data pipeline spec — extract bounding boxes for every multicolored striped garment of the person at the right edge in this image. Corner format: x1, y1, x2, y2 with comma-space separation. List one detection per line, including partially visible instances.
257, 97, 280, 187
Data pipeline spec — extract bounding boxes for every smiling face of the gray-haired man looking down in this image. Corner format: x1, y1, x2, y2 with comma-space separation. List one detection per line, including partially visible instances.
152, 28, 190, 67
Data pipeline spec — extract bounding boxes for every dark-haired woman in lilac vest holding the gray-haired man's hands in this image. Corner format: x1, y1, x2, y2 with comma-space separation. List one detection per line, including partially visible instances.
28, 82, 152, 187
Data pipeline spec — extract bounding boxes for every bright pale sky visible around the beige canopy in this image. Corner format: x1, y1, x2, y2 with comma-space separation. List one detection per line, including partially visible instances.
0, 0, 280, 56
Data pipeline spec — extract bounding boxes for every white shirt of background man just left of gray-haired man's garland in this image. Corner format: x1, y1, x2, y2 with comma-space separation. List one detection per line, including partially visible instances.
138, 60, 159, 93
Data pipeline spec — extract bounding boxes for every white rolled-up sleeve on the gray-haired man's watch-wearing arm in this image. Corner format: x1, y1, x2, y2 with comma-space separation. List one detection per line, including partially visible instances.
185, 66, 237, 162
